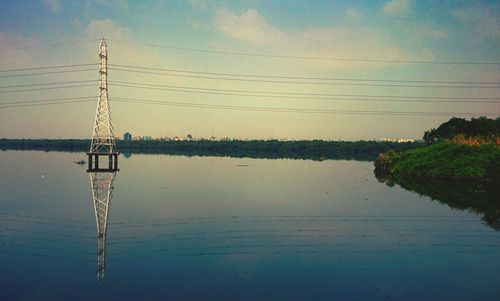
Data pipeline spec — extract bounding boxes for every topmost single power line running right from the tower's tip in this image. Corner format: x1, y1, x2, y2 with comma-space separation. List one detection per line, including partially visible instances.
108, 39, 500, 65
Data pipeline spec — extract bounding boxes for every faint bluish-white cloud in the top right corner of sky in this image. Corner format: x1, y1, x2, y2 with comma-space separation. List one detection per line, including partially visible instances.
452, 5, 500, 37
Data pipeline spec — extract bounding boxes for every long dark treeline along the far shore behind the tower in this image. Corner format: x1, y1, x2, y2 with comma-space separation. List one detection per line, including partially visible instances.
0, 139, 422, 161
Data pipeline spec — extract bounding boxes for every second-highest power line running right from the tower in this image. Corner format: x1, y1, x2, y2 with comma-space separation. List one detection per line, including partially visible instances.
109, 64, 500, 85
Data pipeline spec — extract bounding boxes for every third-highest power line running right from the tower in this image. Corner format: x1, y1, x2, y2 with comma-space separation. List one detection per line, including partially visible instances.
109, 67, 500, 89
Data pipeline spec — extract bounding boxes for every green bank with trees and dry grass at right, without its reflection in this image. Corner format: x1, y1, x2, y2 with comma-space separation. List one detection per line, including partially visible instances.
375, 117, 500, 183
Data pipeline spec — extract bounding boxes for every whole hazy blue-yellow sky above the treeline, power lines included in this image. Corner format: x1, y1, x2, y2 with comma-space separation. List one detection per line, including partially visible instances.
0, 0, 500, 140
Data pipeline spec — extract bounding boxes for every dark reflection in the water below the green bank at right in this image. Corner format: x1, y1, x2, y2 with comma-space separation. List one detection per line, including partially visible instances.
376, 174, 500, 230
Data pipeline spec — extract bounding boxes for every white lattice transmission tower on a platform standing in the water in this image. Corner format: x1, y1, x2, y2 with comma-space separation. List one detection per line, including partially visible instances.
87, 38, 119, 172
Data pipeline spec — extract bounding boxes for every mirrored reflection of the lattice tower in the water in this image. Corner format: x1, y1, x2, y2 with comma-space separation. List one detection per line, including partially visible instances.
90, 172, 116, 285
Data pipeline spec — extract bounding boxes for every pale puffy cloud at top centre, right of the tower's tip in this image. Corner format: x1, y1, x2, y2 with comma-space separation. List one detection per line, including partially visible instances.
214, 8, 286, 44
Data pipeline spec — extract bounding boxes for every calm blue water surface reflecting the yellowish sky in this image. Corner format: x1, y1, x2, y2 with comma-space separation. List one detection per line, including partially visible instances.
0, 151, 500, 300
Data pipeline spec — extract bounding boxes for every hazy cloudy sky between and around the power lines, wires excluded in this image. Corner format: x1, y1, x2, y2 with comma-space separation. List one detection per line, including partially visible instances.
0, 0, 500, 139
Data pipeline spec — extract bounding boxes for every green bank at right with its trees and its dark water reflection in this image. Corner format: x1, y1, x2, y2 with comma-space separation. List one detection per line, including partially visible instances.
375, 118, 500, 230
